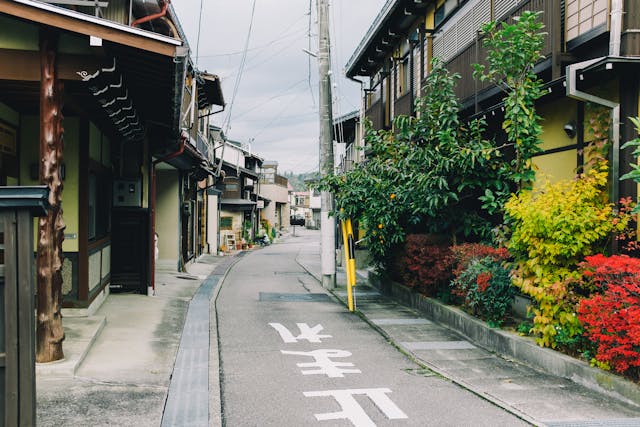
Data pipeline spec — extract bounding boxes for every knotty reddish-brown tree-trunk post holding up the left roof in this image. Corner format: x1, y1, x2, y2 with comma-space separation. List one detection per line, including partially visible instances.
36, 28, 65, 363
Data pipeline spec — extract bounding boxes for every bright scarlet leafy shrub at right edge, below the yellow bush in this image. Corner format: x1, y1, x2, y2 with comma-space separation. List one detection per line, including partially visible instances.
578, 255, 640, 378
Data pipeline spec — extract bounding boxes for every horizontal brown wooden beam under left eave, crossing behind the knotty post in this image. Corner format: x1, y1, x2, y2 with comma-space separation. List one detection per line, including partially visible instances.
0, 49, 102, 82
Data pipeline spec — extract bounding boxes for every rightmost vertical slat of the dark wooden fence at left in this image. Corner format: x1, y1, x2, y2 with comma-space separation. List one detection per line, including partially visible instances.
16, 210, 36, 426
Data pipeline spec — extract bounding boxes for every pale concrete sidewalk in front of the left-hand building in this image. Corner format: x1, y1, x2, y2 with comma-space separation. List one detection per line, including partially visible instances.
36, 255, 233, 426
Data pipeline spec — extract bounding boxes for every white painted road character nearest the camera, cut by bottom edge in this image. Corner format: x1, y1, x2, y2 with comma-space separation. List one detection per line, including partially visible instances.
304, 388, 409, 427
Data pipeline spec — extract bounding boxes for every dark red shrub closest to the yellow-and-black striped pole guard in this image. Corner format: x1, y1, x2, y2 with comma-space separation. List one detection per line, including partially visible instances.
395, 234, 453, 295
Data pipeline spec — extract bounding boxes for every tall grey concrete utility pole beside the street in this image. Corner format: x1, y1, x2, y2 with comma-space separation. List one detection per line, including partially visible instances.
318, 0, 336, 289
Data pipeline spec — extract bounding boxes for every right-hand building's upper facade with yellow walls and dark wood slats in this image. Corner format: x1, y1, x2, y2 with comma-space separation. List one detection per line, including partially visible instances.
346, 0, 640, 206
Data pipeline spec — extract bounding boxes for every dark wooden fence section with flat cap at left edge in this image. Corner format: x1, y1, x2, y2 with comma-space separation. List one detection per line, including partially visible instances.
0, 186, 49, 426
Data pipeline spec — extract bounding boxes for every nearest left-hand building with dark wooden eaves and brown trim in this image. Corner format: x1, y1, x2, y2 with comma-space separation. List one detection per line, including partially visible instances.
0, 0, 224, 313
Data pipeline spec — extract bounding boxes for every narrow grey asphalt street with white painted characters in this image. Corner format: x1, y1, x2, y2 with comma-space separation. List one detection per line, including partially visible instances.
216, 232, 526, 426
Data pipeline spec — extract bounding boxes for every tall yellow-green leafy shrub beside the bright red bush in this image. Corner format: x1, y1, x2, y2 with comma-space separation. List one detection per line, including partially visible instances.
506, 166, 628, 348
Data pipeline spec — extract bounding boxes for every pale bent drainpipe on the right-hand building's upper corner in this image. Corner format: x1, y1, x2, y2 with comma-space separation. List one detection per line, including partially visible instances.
565, 0, 624, 207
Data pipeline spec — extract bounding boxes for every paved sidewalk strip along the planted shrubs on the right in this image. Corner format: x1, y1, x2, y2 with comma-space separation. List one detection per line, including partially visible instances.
297, 245, 640, 427
